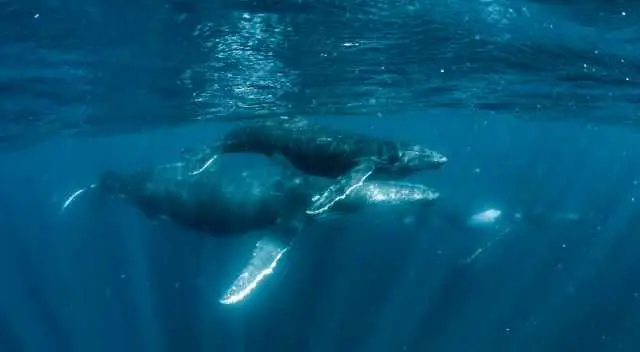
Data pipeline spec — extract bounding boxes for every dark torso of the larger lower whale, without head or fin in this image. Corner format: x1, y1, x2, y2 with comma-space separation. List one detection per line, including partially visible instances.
99, 154, 308, 235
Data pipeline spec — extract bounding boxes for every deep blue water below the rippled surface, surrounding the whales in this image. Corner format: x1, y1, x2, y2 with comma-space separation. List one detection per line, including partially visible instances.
0, 111, 640, 351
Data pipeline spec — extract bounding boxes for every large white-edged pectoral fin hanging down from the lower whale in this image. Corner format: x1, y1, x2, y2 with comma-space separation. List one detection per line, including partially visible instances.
220, 236, 289, 304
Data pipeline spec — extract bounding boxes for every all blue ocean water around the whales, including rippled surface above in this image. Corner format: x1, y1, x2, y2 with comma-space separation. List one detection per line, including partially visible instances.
0, 0, 640, 352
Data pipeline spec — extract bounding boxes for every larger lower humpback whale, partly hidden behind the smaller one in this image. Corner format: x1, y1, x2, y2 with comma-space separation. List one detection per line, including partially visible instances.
65, 154, 438, 304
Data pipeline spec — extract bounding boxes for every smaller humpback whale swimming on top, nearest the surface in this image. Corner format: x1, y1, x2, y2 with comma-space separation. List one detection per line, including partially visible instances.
186, 118, 447, 214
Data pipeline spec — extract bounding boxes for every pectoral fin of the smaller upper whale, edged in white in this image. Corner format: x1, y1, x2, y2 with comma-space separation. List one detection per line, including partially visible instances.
307, 160, 376, 215
